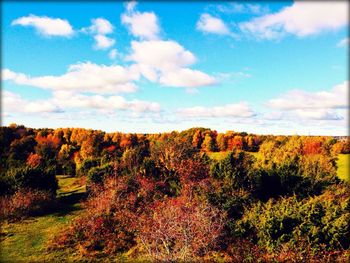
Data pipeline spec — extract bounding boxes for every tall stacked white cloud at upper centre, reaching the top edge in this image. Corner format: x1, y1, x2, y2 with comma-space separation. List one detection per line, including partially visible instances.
121, 2, 216, 89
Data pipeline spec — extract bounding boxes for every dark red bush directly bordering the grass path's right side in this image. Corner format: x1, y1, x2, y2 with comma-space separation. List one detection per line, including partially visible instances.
52, 178, 137, 254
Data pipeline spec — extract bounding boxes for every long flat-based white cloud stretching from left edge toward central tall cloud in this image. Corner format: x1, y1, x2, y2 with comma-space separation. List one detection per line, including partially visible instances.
2, 62, 139, 94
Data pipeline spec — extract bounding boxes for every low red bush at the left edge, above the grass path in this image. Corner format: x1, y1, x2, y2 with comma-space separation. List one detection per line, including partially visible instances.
0, 189, 53, 220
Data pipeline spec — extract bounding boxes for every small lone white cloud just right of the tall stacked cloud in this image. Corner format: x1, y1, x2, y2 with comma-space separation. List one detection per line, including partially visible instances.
196, 14, 230, 35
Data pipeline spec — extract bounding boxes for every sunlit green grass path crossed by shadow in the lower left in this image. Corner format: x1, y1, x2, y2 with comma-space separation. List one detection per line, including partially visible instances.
0, 176, 85, 262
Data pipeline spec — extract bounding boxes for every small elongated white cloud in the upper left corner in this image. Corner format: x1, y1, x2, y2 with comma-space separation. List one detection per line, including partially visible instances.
11, 15, 74, 37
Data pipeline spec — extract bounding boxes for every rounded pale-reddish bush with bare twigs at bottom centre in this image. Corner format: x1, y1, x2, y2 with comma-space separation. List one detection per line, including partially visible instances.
138, 195, 224, 261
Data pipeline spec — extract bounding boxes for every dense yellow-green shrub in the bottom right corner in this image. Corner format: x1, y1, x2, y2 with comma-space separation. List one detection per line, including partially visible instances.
237, 185, 350, 255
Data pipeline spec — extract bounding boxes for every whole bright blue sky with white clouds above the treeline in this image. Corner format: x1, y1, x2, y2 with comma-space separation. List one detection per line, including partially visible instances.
1, 1, 349, 135
